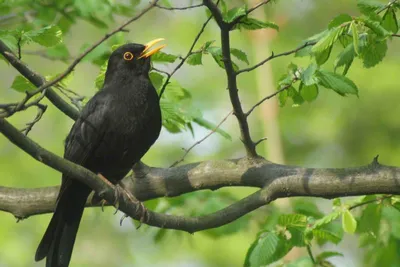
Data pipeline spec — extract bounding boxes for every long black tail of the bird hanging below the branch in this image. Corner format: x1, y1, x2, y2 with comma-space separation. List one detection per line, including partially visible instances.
35, 179, 91, 267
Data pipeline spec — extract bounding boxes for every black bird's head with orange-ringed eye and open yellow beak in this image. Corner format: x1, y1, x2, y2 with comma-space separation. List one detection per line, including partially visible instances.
106, 38, 165, 80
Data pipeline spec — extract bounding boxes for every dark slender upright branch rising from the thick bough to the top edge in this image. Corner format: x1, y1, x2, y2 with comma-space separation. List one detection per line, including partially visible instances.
203, 0, 258, 158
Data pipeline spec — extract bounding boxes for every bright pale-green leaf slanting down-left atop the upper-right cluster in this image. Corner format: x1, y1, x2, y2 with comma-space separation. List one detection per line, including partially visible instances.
312, 27, 343, 65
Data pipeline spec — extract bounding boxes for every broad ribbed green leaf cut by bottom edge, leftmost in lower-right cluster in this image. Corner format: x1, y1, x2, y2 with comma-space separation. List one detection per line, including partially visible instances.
244, 232, 292, 267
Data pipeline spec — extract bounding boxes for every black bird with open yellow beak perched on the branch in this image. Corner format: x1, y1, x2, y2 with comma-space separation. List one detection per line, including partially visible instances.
35, 39, 164, 267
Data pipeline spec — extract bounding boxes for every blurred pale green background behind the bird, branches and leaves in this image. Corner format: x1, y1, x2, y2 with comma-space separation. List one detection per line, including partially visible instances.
0, 0, 400, 267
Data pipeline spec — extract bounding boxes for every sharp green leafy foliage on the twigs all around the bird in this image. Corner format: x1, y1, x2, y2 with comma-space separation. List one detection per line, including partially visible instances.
0, 0, 400, 267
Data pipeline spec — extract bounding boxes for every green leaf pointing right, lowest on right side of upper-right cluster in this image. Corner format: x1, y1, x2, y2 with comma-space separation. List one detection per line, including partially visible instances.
317, 70, 358, 96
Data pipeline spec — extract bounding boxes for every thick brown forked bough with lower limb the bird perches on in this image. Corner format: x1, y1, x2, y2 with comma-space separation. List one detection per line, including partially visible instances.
0, 119, 400, 233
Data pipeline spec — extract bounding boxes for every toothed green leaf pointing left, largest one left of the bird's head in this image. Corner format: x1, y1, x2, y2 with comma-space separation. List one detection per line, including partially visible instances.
23, 25, 62, 47
